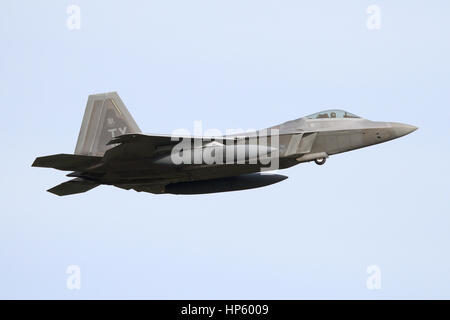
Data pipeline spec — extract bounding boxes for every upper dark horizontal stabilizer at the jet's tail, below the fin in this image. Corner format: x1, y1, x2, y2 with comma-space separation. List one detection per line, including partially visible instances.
32, 153, 102, 171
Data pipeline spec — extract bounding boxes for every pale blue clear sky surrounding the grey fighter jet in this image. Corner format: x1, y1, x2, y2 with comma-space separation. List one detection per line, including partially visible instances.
0, 0, 450, 299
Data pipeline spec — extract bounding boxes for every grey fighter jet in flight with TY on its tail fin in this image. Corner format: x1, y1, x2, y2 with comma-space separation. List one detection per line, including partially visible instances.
32, 92, 417, 196
